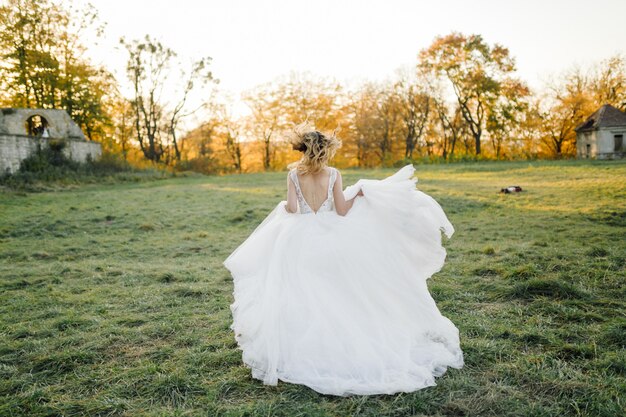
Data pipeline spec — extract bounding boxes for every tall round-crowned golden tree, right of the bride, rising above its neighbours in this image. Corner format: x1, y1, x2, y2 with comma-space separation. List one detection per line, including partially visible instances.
419, 32, 515, 155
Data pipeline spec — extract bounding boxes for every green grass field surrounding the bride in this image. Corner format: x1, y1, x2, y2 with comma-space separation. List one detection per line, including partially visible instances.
0, 161, 626, 417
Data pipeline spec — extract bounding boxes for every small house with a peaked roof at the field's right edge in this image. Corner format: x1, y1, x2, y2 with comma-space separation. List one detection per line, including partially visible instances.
574, 104, 626, 159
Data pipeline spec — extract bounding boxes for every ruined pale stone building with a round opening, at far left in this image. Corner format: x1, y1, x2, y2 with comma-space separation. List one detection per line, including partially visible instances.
0, 109, 102, 175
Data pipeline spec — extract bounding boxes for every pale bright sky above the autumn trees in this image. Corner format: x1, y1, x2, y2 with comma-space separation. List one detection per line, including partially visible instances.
85, 0, 626, 111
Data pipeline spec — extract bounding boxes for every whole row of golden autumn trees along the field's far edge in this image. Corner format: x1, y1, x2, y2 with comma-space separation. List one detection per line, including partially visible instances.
0, 0, 626, 173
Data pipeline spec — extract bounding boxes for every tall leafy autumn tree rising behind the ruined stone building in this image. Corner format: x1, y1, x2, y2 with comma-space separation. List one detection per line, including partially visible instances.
0, 0, 115, 140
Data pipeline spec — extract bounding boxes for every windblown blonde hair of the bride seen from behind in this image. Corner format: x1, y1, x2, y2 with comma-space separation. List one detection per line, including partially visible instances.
287, 122, 341, 174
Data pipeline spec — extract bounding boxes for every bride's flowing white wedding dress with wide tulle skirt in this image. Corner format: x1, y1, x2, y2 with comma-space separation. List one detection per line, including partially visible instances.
224, 165, 463, 396
